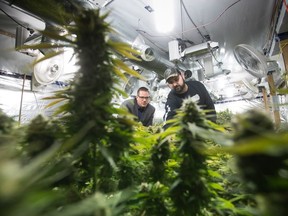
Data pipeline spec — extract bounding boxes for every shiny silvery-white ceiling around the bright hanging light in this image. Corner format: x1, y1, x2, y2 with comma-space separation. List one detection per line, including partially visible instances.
96, 0, 279, 70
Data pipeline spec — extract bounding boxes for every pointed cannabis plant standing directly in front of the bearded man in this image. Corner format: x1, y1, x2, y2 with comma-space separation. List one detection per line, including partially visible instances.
171, 100, 212, 215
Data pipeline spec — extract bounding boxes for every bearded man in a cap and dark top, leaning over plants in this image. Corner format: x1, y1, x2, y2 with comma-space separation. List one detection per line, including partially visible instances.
164, 68, 216, 128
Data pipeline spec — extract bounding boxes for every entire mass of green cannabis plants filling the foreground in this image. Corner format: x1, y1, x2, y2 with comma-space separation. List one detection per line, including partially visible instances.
0, 0, 288, 216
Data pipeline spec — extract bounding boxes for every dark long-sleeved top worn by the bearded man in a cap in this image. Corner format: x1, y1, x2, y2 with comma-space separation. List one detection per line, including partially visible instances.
164, 80, 216, 122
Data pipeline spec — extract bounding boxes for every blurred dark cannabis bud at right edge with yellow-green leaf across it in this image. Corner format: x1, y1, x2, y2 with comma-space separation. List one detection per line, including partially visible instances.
232, 109, 288, 216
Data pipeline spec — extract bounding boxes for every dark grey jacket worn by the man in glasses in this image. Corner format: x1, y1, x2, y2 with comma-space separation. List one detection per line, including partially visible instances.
120, 99, 155, 126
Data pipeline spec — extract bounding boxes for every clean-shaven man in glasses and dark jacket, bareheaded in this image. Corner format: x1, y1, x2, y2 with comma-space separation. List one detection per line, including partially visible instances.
120, 87, 155, 126
